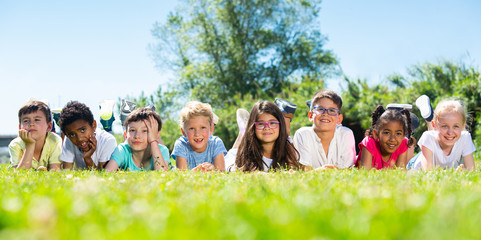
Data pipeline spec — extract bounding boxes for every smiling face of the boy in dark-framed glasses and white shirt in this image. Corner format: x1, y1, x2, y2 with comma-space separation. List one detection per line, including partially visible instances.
308, 98, 342, 132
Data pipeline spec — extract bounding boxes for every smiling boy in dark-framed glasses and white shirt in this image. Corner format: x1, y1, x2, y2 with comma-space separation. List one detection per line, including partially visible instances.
294, 89, 356, 170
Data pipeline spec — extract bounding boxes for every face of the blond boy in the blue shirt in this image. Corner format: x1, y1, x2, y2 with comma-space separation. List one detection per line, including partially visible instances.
181, 116, 212, 153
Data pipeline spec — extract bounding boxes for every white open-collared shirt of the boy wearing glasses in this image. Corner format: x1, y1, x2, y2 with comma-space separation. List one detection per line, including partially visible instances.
294, 125, 356, 169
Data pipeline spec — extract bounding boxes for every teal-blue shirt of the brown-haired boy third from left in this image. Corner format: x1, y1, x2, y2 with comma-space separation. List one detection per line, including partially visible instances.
110, 143, 171, 171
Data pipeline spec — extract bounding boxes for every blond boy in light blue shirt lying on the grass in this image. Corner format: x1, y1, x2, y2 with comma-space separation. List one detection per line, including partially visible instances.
171, 101, 227, 171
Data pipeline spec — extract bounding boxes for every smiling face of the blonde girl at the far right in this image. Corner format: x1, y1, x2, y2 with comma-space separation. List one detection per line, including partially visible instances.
434, 112, 466, 149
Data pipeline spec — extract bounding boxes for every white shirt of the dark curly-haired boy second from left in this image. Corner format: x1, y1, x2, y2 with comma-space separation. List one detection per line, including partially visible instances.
60, 129, 117, 169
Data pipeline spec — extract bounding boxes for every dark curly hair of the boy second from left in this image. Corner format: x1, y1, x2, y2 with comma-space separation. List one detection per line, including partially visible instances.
58, 101, 94, 132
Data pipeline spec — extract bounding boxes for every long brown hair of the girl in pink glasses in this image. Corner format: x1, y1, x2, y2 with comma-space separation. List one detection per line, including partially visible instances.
235, 101, 300, 171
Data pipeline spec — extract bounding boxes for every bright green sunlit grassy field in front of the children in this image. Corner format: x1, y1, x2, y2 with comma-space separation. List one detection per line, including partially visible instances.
0, 165, 481, 240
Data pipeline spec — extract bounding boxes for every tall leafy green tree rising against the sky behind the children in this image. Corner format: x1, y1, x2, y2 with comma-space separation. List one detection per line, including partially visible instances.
152, 0, 337, 107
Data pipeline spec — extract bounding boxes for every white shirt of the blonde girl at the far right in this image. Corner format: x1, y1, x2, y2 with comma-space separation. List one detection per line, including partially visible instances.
413, 131, 476, 169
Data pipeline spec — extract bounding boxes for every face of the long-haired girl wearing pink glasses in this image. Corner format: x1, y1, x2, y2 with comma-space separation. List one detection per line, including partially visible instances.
255, 113, 279, 144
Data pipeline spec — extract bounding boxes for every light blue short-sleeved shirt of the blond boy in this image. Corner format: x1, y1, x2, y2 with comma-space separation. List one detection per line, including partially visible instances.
172, 136, 227, 169
